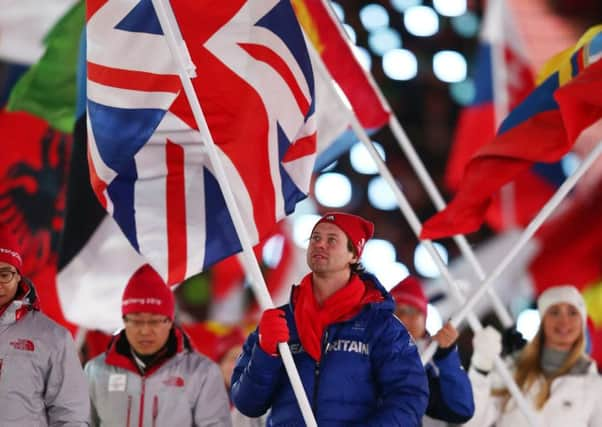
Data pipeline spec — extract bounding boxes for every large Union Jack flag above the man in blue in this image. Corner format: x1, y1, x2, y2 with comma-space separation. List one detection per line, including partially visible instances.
87, 0, 316, 284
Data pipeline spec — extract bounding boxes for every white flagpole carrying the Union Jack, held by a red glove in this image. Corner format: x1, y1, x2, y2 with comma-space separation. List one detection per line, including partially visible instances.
152, 0, 317, 427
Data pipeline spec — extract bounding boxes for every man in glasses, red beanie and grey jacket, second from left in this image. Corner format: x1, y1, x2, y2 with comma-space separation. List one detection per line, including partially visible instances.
85, 264, 231, 427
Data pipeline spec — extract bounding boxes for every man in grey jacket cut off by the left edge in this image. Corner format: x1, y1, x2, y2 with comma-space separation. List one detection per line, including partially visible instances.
0, 228, 90, 427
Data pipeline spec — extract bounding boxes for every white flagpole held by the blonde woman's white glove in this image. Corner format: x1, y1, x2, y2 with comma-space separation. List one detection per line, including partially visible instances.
308, 39, 536, 426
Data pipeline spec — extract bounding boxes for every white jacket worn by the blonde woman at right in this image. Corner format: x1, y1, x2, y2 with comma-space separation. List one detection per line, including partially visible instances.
464, 362, 602, 427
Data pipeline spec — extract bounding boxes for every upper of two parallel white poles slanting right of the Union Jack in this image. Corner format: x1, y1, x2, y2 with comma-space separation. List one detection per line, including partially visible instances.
321, 0, 514, 328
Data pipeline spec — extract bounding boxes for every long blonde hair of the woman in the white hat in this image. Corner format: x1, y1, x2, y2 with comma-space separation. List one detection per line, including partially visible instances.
492, 322, 585, 410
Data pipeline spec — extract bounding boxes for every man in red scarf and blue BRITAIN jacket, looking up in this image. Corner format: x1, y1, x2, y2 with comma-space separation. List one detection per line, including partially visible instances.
231, 212, 428, 427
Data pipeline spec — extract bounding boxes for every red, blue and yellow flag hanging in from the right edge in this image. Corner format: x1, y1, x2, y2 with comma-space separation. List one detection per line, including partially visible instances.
421, 26, 602, 239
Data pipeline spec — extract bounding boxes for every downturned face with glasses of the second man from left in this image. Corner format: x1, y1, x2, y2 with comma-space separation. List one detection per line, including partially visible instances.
123, 313, 173, 356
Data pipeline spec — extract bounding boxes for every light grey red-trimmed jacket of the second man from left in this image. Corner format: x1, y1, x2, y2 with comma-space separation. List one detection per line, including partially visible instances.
85, 328, 232, 427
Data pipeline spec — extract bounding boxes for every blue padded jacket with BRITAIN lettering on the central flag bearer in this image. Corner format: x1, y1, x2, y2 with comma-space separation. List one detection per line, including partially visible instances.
231, 274, 428, 427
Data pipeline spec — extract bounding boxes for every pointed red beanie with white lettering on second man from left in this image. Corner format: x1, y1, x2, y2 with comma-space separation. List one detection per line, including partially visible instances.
121, 264, 174, 320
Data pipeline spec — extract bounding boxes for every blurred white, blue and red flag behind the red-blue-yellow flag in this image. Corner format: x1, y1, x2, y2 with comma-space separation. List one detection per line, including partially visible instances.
445, 0, 565, 232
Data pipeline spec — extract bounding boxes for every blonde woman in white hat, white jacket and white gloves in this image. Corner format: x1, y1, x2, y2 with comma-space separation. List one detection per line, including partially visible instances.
464, 286, 602, 427
